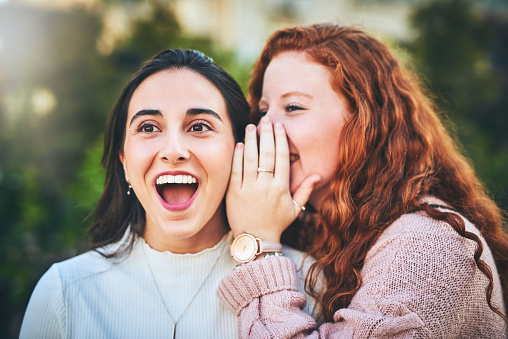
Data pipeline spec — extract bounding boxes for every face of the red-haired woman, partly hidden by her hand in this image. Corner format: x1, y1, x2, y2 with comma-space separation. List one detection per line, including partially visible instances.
259, 52, 349, 208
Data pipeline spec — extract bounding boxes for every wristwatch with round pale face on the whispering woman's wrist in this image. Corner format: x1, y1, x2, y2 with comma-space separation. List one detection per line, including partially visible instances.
230, 233, 282, 264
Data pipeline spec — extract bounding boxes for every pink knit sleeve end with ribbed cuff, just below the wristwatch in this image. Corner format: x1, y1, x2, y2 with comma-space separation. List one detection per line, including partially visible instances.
217, 257, 322, 338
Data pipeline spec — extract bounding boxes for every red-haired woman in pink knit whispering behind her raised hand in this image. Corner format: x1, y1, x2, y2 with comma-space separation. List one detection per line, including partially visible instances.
218, 24, 508, 338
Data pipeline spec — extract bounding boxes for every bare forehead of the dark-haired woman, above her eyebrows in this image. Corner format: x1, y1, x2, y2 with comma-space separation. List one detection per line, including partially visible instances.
128, 69, 228, 119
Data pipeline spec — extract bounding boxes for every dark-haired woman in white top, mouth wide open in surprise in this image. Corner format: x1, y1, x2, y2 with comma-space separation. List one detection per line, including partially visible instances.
20, 50, 318, 338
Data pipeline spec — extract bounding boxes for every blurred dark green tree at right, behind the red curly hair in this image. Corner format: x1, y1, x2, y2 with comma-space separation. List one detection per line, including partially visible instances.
410, 0, 508, 209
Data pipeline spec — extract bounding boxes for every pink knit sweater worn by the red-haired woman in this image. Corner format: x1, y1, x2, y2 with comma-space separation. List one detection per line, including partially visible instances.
217, 207, 506, 339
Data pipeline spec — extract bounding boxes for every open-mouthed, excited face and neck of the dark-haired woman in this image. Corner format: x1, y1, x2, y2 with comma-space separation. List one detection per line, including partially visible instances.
120, 69, 235, 253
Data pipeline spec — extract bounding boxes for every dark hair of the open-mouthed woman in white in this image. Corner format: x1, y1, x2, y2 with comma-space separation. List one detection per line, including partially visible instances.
82, 49, 250, 257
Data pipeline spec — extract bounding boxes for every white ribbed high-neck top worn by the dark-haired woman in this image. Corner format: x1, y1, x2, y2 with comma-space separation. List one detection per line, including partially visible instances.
20, 233, 318, 339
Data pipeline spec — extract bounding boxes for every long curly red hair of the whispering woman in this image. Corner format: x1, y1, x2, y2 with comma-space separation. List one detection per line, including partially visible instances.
249, 24, 508, 321
